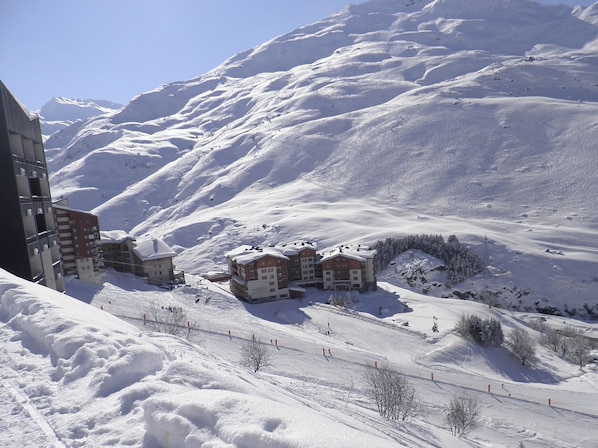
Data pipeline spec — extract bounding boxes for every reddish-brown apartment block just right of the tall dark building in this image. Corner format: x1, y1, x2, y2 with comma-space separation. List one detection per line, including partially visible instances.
54, 199, 104, 284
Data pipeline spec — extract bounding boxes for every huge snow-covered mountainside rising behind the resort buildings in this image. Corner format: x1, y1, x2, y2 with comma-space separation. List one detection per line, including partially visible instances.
46, 0, 598, 316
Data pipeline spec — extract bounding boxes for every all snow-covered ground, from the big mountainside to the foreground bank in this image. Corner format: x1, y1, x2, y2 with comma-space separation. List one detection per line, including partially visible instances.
0, 0, 598, 448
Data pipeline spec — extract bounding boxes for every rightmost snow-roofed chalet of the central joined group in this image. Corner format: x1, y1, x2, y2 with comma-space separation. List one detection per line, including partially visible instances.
320, 246, 376, 291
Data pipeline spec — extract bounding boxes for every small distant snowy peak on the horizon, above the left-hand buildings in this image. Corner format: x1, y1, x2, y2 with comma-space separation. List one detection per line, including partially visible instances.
38, 97, 123, 138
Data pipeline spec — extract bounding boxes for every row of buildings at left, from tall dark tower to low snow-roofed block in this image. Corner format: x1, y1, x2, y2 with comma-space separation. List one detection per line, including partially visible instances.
0, 82, 183, 291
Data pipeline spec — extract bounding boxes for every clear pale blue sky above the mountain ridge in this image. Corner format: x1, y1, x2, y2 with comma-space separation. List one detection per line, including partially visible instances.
0, 0, 593, 111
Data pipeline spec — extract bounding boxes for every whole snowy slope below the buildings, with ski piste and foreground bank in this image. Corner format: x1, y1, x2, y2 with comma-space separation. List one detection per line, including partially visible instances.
0, 262, 598, 448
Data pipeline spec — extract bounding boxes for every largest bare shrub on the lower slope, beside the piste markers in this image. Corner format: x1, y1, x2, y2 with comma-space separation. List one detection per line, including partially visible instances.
364, 367, 422, 421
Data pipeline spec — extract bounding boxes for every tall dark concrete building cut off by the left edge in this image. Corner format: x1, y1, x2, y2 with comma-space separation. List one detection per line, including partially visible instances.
0, 82, 64, 291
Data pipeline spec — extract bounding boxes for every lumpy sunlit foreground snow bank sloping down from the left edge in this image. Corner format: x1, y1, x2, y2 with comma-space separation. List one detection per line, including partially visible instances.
0, 271, 404, 448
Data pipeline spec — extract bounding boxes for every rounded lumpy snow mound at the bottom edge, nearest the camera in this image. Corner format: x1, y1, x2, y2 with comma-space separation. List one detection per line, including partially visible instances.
143, 390, 391, 448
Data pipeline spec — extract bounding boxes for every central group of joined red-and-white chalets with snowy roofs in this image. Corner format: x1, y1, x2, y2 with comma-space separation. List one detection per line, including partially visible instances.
226, 242, 376, 302
